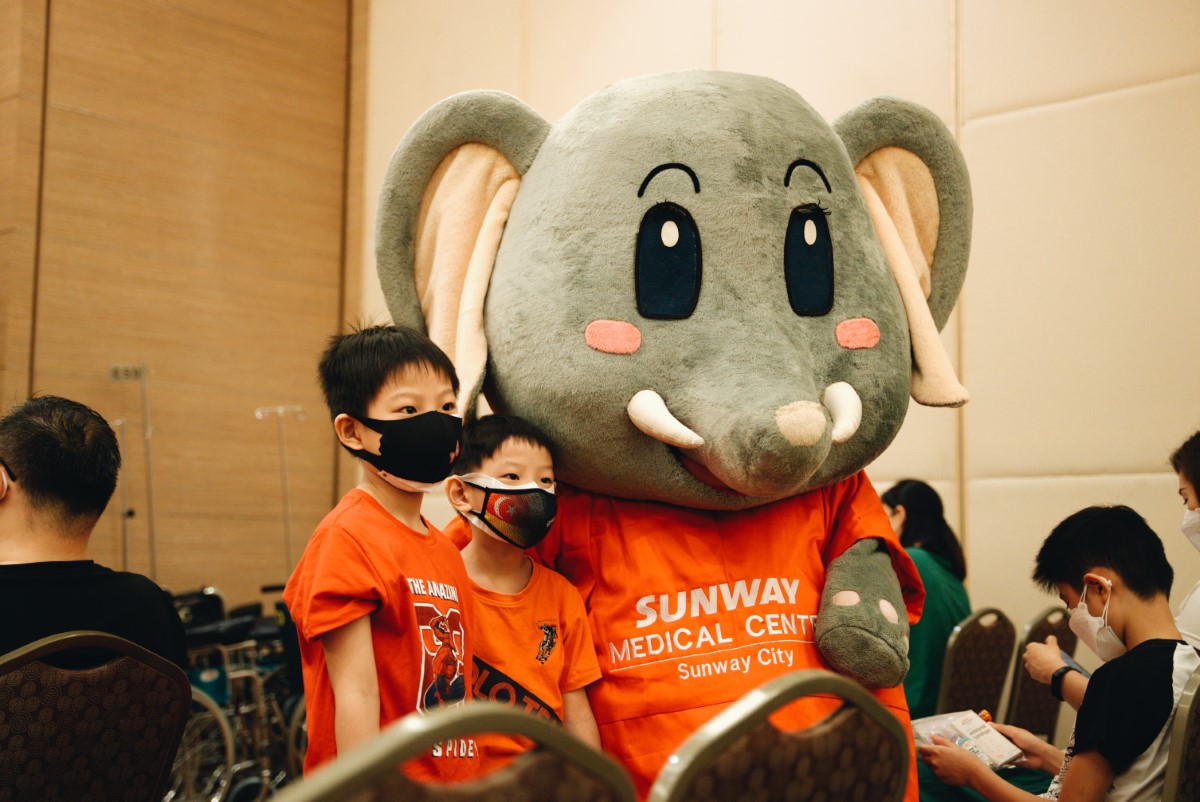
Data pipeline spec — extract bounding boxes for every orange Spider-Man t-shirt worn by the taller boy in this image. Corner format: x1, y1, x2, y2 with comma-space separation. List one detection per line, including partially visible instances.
283, 489, 478, 780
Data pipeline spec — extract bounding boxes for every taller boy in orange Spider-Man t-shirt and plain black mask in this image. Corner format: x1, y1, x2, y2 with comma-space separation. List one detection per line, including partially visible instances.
283, 327, 478, 780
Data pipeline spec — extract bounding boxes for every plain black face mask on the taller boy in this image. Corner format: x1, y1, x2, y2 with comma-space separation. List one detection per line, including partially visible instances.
352, 411, 462, 483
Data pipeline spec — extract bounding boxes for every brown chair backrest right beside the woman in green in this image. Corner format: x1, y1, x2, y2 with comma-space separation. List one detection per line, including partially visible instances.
937, 608, 1016, 718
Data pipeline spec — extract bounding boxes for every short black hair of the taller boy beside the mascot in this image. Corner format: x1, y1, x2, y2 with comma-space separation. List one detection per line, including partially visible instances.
317, 325, 458, 419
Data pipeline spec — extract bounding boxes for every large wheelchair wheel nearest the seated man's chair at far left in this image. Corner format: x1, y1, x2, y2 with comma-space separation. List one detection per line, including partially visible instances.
163, 688, 233, 802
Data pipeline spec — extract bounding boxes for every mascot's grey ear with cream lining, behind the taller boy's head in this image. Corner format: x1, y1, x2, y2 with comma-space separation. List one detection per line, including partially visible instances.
376, 91, 550, 415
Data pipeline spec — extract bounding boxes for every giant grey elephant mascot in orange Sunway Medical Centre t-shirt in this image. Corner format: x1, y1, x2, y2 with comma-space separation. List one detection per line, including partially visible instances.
377, 72, 971, 800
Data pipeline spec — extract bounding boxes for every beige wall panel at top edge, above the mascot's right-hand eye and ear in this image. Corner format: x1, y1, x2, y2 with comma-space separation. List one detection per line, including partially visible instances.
697, 0, 954, 125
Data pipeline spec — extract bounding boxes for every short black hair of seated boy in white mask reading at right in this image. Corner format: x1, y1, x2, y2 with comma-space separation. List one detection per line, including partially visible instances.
1033, 505, 1175, 599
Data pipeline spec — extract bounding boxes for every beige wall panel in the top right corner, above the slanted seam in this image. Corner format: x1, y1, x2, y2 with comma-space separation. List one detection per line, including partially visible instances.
961, 0, 1200, 119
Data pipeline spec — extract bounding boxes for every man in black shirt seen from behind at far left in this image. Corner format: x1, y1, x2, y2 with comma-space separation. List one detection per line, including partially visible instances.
0, 395, 187, 670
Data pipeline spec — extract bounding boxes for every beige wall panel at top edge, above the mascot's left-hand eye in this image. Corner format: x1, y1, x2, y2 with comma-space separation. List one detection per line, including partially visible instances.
523, 0, 715, 121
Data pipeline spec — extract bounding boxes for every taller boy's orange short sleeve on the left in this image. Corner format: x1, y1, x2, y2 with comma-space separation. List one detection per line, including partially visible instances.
283, 527, 386, 640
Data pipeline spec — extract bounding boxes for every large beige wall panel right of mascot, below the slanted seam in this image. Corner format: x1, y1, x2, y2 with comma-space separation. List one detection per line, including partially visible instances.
965, 76, 1200, 478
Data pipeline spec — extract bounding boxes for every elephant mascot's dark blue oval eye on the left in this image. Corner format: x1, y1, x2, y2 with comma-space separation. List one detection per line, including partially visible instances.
634, 203, 700, 321
